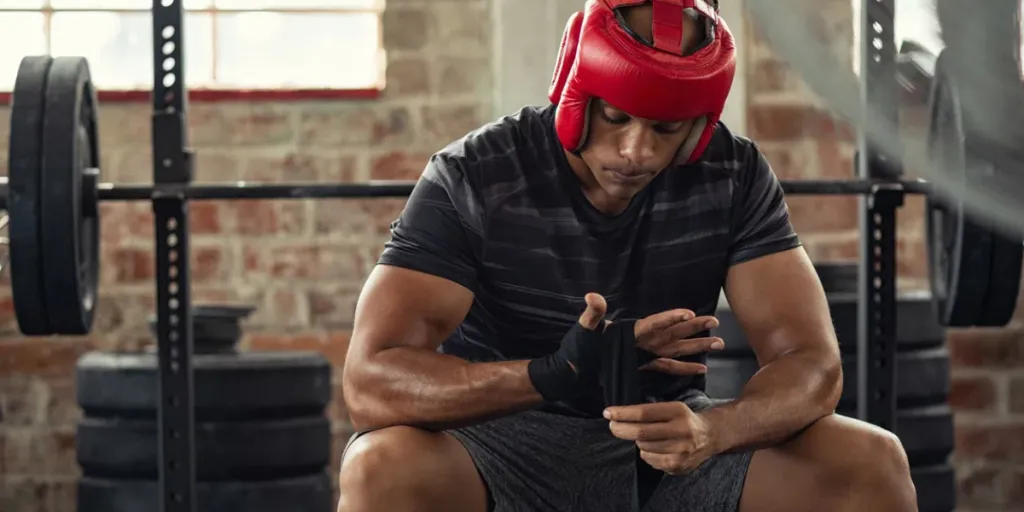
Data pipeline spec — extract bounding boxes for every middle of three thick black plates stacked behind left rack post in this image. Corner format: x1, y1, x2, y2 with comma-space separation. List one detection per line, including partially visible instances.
76, 416, 331, 481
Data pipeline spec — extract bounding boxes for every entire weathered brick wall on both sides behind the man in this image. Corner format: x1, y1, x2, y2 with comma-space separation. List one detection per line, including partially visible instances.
0, 0, 1024, 512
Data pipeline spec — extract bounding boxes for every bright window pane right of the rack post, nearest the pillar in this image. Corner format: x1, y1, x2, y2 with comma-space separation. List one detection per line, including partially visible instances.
217, 12, 381, 88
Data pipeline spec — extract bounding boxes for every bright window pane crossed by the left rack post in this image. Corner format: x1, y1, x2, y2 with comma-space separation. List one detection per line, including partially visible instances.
51, 12, 213, 89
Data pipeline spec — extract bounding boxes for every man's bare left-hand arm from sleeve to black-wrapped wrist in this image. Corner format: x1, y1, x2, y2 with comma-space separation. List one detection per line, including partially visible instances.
343, 265, 543, 430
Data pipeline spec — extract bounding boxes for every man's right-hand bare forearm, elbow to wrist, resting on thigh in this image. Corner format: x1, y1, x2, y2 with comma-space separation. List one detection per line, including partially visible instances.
702, 350, 843, 452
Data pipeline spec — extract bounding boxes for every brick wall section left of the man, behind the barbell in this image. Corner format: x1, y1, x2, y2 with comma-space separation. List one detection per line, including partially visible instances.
0, 0, 492, 512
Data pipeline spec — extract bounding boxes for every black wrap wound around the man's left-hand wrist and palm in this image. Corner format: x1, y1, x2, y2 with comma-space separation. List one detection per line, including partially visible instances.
526, 323, 605, 401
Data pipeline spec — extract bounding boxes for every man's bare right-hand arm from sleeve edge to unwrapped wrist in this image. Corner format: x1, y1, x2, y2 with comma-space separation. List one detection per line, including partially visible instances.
705, 248, 843, 452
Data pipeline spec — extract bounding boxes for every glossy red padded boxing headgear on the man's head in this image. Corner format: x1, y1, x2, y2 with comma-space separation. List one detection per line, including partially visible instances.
548, 0, 736, 163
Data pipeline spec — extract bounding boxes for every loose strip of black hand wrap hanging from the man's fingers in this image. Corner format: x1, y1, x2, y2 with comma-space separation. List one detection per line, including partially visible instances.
601, 321, 664, 512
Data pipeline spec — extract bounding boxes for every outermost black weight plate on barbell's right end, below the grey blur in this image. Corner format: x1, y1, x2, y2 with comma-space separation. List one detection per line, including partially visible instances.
977, 232, 1024, 327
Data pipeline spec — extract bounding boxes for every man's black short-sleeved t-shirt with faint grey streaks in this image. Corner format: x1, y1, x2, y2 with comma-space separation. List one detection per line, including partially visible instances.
379, 106, 800, 416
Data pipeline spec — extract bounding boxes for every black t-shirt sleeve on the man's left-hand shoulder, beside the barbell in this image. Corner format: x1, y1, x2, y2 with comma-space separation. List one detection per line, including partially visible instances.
378, 156, 482, 292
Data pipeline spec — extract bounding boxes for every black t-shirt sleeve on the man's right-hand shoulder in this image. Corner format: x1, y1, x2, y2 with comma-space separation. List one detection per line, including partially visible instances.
729, 143, 801, 265
